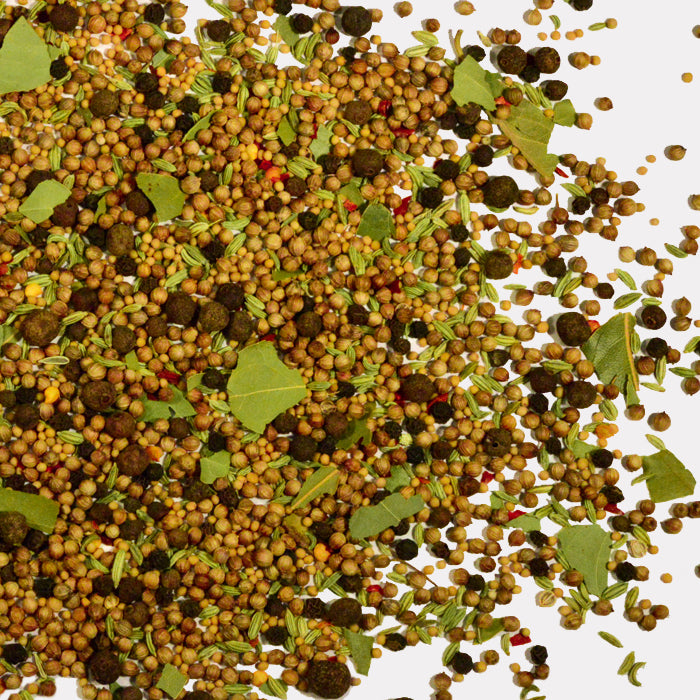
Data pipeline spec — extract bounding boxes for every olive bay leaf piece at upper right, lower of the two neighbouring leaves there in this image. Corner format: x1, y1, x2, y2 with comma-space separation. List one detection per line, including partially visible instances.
495, 100, 559, 176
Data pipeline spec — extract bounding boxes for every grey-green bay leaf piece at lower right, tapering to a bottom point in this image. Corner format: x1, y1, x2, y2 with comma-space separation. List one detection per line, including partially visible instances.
557, 525, 612, 595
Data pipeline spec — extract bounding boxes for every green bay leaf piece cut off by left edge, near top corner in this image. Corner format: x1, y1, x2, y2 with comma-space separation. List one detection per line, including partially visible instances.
0, 17, 51, 95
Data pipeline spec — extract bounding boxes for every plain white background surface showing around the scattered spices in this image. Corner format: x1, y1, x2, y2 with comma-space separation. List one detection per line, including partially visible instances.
46, 0, 700, 700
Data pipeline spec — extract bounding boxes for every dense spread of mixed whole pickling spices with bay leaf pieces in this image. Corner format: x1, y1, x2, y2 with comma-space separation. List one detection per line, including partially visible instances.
0, 0, 700, 700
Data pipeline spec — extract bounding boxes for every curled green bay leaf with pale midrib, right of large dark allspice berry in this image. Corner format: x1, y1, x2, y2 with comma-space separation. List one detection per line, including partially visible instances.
581, 313, 639, 406
